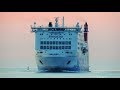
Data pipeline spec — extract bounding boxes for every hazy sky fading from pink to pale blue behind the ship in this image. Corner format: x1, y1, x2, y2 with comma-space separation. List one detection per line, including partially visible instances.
0, 12, 120, 70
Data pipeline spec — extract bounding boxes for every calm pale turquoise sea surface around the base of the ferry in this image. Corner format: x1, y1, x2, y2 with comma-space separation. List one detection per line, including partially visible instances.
0, 68, 120, 78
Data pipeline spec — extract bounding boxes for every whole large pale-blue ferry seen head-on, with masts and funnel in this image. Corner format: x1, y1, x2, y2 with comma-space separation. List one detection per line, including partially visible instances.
31, 17, 89, 71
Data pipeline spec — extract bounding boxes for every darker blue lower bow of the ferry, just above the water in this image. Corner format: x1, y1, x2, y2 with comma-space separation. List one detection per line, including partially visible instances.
36, 56, 88, 72
